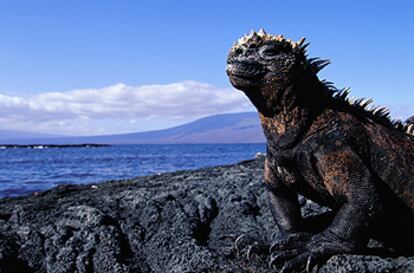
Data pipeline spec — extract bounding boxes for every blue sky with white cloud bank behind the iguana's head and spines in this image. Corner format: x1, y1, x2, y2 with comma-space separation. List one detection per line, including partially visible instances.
0, 0, 414, 135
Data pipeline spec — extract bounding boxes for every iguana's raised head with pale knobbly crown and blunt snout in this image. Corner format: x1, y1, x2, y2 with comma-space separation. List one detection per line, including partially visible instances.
227, 30, 329, 115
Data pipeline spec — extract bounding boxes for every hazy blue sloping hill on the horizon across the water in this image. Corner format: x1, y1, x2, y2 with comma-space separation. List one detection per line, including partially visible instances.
0, 112, 265, 144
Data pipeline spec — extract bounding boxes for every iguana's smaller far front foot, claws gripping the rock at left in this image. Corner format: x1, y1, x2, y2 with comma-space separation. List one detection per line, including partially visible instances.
234, 234, 268, 260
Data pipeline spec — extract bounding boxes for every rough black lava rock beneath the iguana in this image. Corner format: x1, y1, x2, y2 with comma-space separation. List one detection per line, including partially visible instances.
0, 157, 414, 273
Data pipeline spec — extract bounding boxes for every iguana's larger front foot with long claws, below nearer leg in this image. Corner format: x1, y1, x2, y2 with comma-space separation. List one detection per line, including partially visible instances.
269, 233, 356, 273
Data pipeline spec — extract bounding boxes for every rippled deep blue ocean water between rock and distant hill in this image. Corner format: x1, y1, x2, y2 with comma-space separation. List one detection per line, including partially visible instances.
0, 144, 265, 198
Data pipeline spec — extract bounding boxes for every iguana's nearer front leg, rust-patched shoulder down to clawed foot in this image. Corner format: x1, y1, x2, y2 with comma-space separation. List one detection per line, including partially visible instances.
273, 149, 381, 272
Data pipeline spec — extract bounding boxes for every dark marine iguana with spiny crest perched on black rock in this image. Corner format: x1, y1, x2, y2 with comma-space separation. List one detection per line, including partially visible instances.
227, 30, 414, 272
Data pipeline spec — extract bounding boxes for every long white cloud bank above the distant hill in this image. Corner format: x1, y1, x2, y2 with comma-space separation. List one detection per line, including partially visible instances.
0, 81, 253, 135
